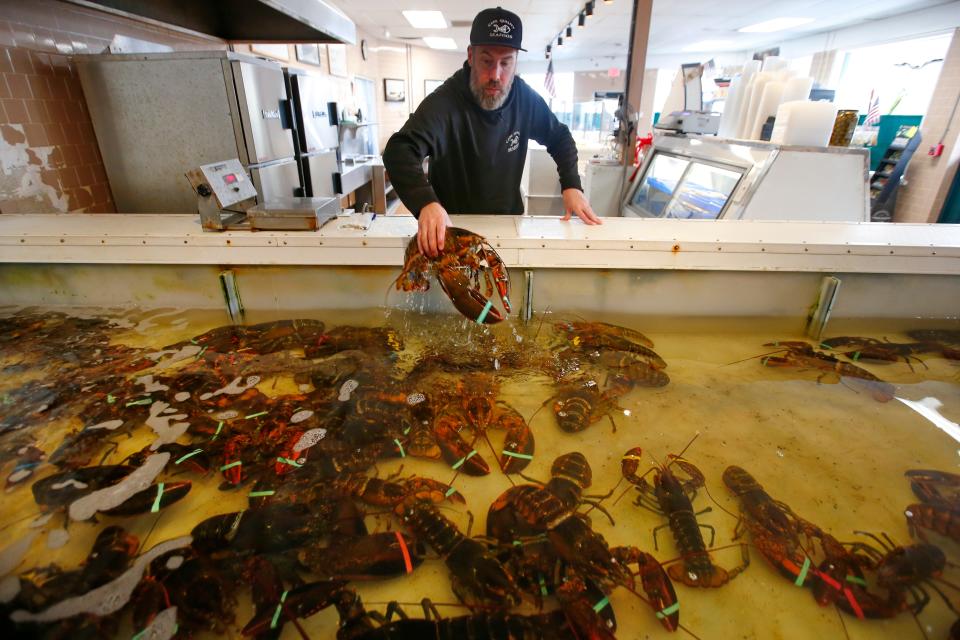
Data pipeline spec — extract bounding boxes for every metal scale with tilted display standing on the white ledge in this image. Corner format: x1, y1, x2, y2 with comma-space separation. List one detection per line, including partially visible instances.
186, 158, 341, 231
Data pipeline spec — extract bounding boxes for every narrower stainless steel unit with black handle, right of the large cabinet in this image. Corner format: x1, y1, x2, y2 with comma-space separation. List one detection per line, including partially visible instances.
284, 68, 341, 197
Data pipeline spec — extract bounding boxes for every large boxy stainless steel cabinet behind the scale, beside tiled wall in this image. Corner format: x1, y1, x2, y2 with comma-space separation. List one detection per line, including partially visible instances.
76, 51, 303, 213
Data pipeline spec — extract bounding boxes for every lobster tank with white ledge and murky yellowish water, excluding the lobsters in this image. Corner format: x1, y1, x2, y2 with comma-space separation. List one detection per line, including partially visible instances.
0, 215, 960, 638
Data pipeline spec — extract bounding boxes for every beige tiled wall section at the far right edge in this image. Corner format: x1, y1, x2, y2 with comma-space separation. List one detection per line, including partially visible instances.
894, 29, 960, 222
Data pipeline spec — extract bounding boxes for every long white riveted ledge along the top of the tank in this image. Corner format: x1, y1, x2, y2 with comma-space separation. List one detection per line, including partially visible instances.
0, 214, 960, 274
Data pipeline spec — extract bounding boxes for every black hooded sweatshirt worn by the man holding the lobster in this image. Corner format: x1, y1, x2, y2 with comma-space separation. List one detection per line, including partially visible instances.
383, 62, 582, 217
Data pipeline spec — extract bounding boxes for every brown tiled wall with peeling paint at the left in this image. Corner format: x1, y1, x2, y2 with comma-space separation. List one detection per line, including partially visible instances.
0, 0, 226, 213
